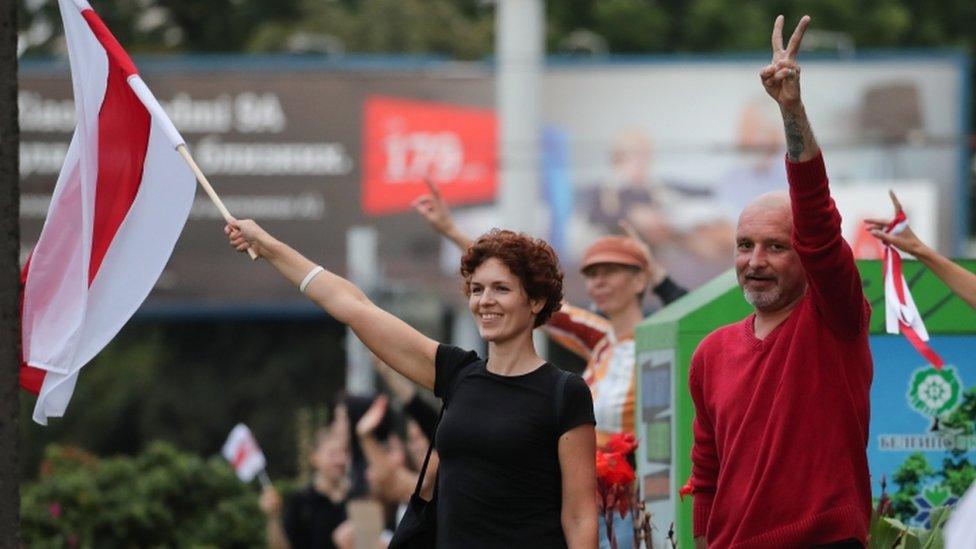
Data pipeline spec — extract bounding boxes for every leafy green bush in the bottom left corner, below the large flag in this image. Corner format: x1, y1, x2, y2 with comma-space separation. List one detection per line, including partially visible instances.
21, 442, 264, 548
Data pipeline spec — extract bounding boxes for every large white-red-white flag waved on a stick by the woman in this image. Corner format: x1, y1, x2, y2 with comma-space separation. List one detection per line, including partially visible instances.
21, 0, 195, 424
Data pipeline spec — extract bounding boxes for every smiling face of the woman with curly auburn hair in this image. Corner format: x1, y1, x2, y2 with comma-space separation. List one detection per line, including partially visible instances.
468, 257, 545, 343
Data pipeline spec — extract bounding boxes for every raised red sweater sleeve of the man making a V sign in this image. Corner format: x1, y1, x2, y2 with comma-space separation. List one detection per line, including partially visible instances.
786, 153, 870, 337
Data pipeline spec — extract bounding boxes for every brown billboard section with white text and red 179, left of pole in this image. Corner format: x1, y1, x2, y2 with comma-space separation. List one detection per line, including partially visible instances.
19, 63, 496, 312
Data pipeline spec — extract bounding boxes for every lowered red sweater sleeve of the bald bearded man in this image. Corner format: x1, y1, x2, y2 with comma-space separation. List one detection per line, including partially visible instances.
688, 352, 718, 538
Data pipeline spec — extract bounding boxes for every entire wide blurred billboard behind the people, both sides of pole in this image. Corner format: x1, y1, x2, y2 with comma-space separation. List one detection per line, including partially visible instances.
19, 53, 968, 309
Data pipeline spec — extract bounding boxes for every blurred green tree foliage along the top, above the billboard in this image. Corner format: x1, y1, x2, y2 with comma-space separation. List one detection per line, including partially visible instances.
18, 0, 976, 59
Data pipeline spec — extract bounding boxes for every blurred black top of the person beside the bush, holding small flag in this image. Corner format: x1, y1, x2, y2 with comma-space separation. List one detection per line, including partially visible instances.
283, 485, 346, 549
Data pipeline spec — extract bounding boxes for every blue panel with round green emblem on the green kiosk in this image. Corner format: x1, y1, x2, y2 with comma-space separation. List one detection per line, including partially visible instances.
868, 335, 976, 527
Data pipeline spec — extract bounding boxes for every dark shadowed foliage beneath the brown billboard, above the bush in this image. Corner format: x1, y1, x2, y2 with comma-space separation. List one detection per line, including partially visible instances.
21, 318, 345, 478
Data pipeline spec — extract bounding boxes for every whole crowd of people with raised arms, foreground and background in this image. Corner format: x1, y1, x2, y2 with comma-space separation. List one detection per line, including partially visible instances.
226, 12, 976, 548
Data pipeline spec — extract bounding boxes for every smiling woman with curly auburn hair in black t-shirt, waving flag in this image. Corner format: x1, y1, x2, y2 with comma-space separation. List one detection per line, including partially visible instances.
225, 220, 597, 548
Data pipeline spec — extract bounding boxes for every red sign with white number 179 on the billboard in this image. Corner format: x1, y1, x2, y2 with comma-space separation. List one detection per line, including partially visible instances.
362, 96, 498, 215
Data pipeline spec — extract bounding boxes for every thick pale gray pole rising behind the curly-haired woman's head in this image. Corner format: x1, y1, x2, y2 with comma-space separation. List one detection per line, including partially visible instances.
495, 0, 545, 233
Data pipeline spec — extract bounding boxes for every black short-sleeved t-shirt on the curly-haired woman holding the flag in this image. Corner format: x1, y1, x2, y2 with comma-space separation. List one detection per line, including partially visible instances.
434, 345, 596, 549
